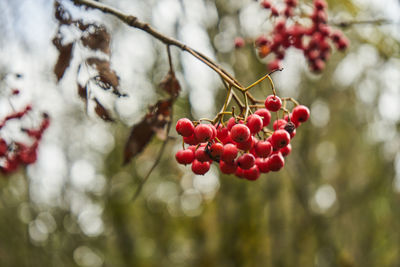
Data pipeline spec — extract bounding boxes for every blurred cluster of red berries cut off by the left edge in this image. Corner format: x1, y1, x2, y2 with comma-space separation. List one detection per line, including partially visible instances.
0, 105, 50, 174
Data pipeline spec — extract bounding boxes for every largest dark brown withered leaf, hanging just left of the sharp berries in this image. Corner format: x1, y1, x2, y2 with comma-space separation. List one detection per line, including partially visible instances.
124, 99, 172, 164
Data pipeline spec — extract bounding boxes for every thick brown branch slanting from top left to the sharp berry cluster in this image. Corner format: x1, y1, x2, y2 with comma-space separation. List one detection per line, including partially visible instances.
71, 0, 243, 89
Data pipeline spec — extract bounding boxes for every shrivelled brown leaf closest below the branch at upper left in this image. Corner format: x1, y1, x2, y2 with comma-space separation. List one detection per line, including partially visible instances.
81, 24, 110, 54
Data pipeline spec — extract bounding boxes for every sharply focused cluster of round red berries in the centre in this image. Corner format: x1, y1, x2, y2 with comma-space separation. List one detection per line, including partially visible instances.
175, 95, 310, 180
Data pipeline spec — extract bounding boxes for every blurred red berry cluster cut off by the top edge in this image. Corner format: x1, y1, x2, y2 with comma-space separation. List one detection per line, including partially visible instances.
235, 0, 349, 72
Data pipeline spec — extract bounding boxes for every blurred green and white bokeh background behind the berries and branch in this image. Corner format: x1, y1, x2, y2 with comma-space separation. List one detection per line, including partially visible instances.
0, 0, 400, 267
